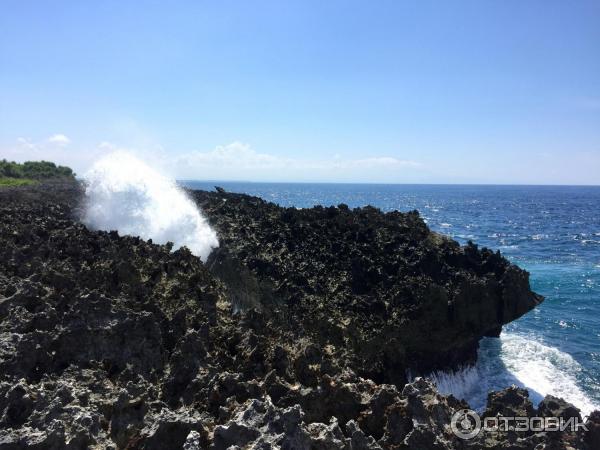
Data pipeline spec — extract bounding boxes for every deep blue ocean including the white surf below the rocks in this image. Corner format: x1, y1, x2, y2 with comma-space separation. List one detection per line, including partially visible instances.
183, 182, 600, 413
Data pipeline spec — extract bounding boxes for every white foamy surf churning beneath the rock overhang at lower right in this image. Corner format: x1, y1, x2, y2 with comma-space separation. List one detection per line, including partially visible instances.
429, 333, 600, 416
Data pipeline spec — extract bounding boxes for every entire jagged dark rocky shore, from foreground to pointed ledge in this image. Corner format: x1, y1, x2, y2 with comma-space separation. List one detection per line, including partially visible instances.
0, 182, 600, 450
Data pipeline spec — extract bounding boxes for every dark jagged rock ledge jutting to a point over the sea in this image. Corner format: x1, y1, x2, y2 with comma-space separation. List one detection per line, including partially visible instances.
193, 190, 542, 383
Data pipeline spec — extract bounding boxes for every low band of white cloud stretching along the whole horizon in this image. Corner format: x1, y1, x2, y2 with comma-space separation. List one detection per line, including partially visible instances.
0, 133, 600, 185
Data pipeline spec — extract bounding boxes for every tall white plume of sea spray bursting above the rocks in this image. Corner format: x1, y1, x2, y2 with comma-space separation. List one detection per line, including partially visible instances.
83, 152, 219, 261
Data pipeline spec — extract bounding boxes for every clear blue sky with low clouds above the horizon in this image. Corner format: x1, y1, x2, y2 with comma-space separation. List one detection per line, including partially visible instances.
0, 0, 600, 184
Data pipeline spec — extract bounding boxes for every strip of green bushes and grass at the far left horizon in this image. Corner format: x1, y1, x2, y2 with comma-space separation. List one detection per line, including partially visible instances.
0, 159, 75, 182
